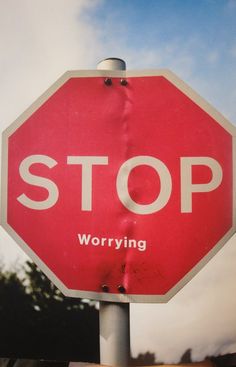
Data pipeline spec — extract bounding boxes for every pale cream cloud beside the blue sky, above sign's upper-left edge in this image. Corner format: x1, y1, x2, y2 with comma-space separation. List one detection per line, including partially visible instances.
0, 0, 103, 125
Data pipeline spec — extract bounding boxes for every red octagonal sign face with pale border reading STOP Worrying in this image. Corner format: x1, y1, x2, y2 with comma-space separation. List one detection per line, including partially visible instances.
1, 70, 235, 302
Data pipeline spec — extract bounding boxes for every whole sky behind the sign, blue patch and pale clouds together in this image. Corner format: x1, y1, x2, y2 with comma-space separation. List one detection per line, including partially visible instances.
0, 0, 236, 363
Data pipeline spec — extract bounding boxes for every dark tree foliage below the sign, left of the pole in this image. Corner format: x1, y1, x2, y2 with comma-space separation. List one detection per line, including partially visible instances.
0, 262, 99, 362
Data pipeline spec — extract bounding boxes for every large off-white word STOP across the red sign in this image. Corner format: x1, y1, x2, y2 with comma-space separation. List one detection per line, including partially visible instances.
17, 155, 223, 215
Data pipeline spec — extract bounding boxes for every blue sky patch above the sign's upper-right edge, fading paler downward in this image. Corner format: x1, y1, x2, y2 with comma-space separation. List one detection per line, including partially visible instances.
88, 0, 236, 121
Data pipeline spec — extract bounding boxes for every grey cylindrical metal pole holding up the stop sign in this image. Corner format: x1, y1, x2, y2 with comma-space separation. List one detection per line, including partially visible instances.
97, 58, 130, 366
